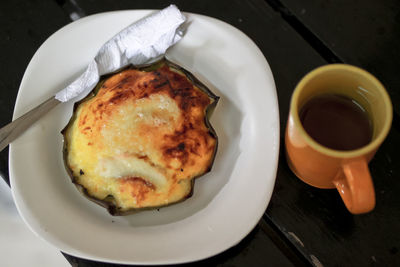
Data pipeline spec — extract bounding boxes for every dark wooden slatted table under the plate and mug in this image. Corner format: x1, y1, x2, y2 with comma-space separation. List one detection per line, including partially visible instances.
0, 0, 400, 266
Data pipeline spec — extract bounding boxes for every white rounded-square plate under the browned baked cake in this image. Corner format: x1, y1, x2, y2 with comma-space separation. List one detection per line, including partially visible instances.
9, 10, 279, 264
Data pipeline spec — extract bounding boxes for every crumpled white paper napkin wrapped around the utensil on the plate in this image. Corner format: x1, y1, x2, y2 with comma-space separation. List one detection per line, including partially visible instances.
55, 5, 186, 102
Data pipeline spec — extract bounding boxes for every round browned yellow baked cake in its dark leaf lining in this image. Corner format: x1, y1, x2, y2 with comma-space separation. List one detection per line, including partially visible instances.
62, 58, 219, 215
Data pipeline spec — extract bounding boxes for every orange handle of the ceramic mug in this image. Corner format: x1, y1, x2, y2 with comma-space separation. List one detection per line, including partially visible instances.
333, 158, 375, 214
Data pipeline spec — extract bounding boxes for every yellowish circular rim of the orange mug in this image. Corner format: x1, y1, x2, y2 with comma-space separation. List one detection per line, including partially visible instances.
290, 63, 393, 158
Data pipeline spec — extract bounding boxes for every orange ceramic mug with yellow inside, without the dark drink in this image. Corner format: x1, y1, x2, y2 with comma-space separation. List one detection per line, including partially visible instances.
285, 64, 393, 214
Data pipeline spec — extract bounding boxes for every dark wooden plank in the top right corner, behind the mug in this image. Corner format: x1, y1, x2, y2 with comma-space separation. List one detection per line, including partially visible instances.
273, 0, 400, 115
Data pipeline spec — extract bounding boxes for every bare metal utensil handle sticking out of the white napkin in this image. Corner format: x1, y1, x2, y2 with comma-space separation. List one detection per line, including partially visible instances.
0, 96, 61, 151
